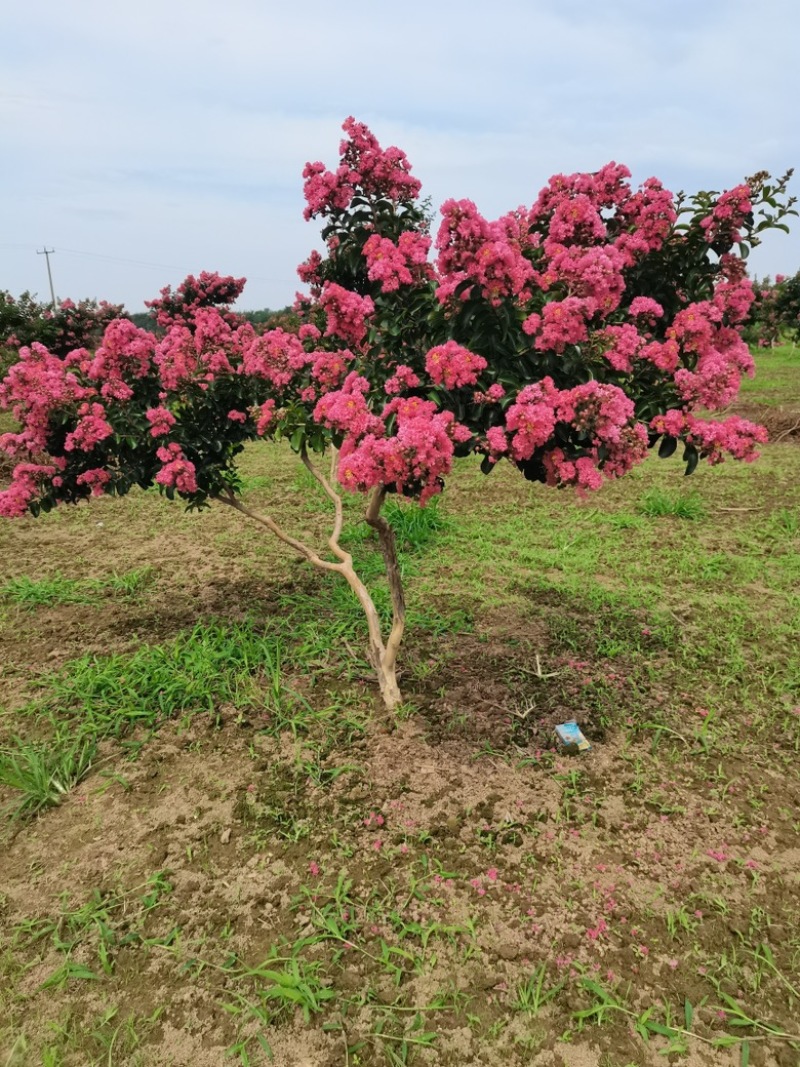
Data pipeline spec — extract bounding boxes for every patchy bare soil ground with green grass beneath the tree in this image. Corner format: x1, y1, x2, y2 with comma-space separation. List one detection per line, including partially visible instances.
0, 350, 800, 1067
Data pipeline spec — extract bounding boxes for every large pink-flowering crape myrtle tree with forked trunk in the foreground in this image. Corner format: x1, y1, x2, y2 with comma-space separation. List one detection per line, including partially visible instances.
0, 118, 791, 708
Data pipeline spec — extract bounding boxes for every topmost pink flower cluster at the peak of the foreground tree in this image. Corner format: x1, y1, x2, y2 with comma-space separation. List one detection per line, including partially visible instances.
303, 117, 420, 219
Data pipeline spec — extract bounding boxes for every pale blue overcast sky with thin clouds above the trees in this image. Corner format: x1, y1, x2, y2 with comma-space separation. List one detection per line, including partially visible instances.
0, 0, 800, 312
